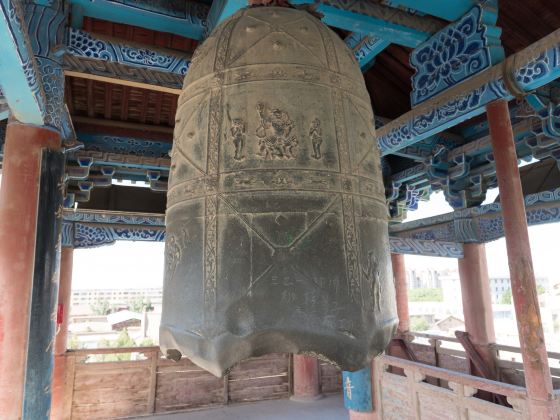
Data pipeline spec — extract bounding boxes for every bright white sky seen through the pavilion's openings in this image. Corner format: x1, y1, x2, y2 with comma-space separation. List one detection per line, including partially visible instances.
72, 190, 560, 289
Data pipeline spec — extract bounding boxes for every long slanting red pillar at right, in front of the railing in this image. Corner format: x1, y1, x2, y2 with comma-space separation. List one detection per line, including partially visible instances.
486, 100, 554, 419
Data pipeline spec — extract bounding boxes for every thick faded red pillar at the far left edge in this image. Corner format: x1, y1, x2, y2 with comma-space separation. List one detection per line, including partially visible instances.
0, 123, 60, 419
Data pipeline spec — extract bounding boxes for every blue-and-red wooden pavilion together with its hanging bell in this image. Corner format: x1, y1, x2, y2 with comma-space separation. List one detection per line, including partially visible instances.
0, 0, 560, 420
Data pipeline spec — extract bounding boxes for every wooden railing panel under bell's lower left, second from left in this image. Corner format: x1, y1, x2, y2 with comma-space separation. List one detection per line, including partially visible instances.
155, 359, 224, 412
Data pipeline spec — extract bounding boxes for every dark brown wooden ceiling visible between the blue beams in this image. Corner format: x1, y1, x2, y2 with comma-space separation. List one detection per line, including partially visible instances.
66, 0, 560, 131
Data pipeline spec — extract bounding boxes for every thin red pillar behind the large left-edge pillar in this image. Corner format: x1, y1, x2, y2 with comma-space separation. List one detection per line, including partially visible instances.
51, 248, 74, 420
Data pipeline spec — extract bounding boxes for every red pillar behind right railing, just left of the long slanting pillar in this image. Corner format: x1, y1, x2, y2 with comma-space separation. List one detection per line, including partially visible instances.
458, 244, 496, 379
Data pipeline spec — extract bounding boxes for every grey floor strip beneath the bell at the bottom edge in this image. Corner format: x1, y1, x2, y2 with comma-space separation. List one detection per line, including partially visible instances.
133, 395, 348, 420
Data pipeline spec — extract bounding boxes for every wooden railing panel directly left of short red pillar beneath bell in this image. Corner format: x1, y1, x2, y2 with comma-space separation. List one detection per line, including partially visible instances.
228, 353, 290, 402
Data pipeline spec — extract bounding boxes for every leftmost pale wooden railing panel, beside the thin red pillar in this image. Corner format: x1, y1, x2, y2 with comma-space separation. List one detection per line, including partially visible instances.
71, 361, 150, 420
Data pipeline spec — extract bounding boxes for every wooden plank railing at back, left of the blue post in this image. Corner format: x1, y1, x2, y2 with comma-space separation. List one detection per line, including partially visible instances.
64, 347, 342, 420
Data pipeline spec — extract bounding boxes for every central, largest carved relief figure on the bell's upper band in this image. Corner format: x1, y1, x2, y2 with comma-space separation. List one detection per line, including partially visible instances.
256, 102, 298, 160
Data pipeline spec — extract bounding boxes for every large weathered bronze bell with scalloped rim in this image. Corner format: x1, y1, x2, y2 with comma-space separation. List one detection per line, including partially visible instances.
160, 7, 397, 376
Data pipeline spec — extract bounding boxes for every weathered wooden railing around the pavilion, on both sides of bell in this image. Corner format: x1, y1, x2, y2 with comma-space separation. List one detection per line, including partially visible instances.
59, 333, 560, 420
